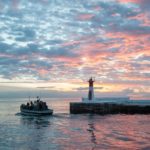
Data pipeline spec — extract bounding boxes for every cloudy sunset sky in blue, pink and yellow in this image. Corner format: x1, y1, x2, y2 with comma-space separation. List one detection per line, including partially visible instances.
0, 0, 150, 99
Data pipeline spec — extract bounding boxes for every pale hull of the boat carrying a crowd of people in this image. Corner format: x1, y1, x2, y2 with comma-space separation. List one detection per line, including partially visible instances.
21, 109, 53, 116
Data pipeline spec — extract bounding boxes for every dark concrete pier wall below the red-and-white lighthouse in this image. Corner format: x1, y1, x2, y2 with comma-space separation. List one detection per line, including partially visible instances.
70, 102, 150, 115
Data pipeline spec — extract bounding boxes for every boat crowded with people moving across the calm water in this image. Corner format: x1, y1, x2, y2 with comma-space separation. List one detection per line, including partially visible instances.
20, 96, 53, 116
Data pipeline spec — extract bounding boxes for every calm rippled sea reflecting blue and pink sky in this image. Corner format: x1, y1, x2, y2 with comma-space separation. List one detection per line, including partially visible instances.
0, 99, 150, 150
